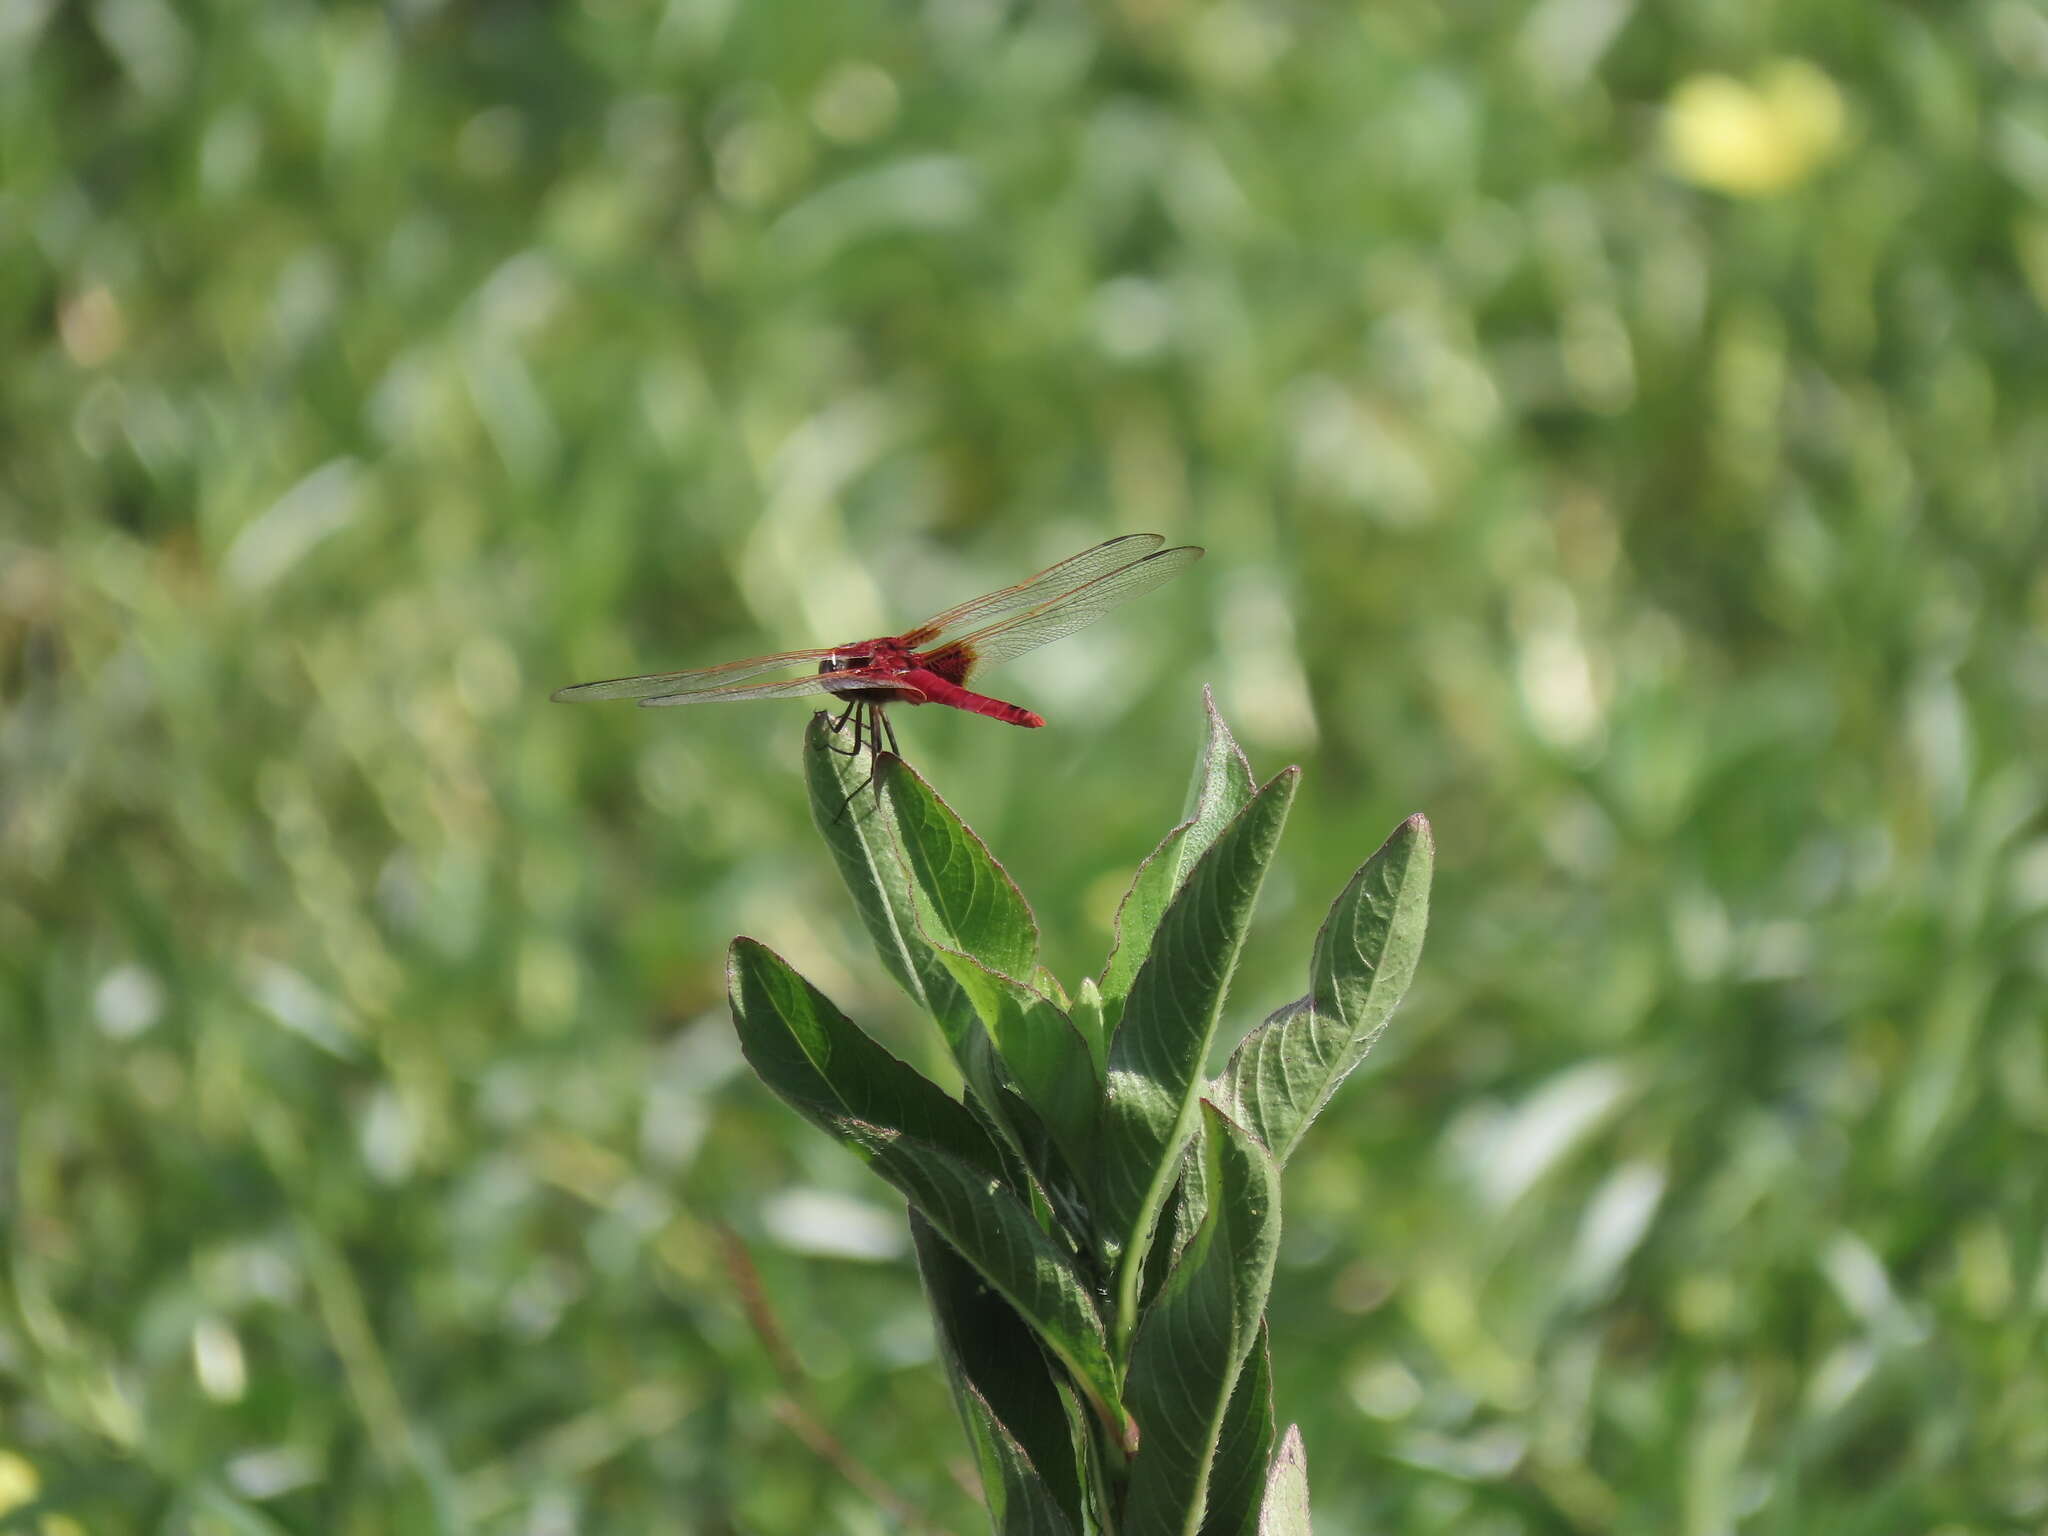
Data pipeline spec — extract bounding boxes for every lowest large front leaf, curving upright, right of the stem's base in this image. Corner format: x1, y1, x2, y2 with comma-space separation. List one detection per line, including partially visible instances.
1118, 1102, 1280, 1536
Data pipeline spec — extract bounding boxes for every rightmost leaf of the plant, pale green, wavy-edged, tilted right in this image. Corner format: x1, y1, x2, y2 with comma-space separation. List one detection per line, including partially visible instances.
1217, 815, 1436, 1163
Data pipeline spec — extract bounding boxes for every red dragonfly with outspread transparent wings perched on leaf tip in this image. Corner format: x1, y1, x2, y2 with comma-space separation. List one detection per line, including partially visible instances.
555, 532, 1202, 754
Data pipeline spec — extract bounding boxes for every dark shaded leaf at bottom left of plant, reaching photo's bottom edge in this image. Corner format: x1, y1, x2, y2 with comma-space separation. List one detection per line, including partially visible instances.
909, 1210, 1083, 1536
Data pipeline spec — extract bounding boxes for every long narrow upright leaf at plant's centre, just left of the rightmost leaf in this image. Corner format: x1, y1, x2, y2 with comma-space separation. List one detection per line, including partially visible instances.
1096, 768, 1300, 1337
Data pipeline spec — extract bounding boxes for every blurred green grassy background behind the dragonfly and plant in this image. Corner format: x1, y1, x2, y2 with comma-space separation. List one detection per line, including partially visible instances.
0, 0, 2048, 1536
